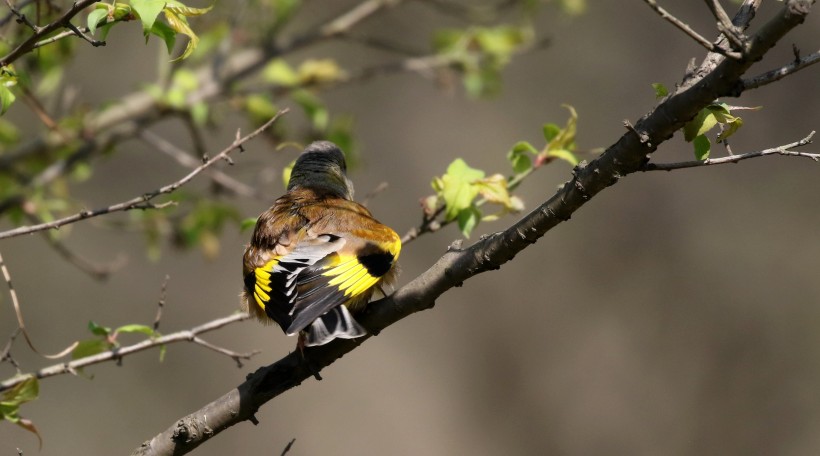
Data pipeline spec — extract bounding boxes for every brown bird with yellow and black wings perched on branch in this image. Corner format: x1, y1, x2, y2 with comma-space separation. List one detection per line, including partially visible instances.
241, 141, 401, 350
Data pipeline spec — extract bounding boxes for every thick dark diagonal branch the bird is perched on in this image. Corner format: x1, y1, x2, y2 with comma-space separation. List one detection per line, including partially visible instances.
133, 0, 812, 455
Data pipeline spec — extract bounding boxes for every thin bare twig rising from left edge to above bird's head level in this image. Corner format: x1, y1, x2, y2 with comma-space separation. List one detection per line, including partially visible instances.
0, 109, 287, 239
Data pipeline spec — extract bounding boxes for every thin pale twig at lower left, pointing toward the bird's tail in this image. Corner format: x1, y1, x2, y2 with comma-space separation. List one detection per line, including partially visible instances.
0, 313, 255, 392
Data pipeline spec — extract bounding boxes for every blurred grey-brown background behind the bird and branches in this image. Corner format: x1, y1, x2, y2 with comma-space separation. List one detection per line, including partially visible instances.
0, 0, 820, 455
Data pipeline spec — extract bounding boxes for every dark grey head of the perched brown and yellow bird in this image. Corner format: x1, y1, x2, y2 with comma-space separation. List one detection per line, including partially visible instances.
288, 141, 353, 199
